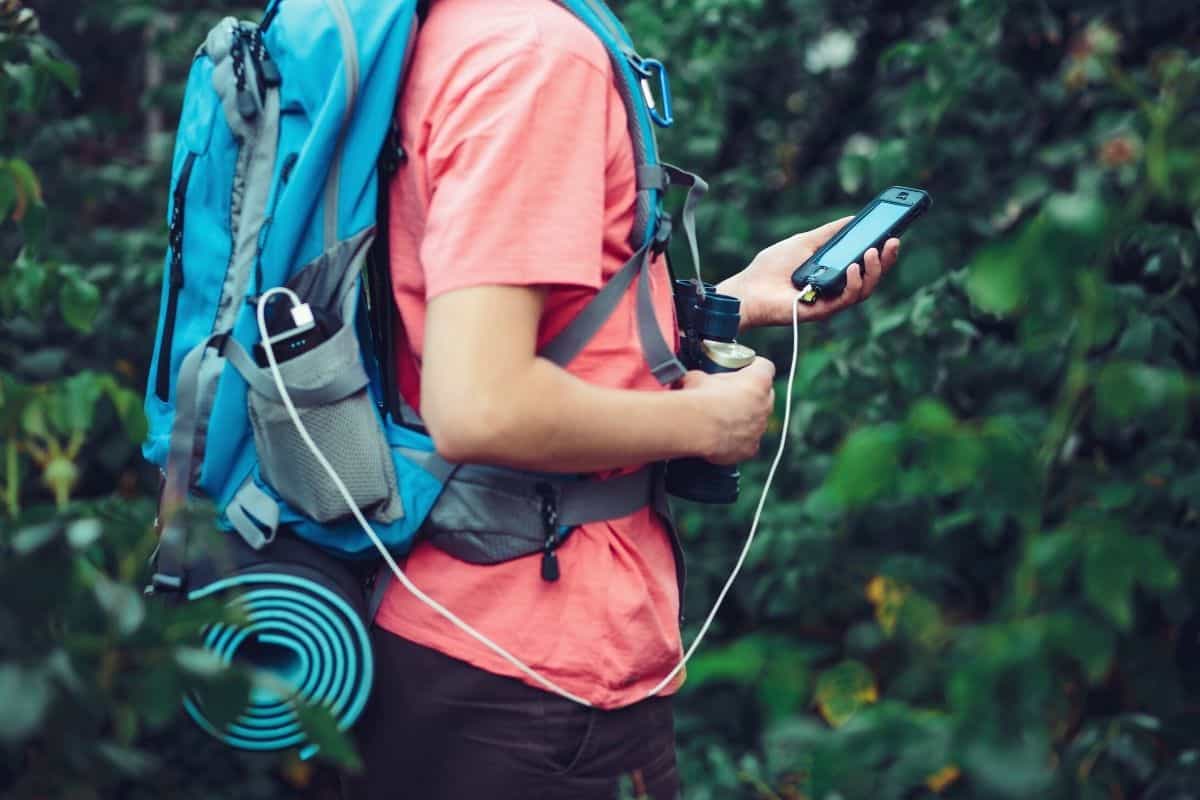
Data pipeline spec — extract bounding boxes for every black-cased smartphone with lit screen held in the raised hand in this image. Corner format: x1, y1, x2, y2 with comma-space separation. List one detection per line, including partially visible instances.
792, 186, 934, 303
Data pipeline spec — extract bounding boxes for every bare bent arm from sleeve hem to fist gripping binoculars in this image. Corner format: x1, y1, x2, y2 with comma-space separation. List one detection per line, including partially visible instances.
421, 285, 774, 473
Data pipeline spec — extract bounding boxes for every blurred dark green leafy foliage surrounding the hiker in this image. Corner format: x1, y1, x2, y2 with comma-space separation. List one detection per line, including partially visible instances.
0, 0, 1200, 800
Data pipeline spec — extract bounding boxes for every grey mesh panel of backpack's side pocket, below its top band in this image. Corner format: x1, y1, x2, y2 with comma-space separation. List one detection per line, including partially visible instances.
250, 389, 397, 522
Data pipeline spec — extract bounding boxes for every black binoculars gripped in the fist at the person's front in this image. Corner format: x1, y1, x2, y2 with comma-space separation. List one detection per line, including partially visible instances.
666, 281, 755, 504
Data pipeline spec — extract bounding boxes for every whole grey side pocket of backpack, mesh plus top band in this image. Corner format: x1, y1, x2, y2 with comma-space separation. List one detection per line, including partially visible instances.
248, 323, 403, 522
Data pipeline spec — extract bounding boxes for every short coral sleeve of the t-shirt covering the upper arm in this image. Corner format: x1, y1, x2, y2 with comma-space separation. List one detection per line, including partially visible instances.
421, 42, 610, 297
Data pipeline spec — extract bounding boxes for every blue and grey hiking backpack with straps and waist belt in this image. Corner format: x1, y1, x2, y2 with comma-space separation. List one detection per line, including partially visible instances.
144, 0, 704, 599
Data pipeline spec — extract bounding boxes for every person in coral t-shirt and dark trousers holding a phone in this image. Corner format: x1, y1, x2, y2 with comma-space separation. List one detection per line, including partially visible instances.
359, 0, 899, 800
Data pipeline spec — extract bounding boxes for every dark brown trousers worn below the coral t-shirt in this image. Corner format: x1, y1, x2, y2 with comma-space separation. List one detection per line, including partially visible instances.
349, 627, 679, 800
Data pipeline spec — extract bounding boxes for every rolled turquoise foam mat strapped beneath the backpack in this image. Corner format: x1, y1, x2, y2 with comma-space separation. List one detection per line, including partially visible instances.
184, 536, 374, 758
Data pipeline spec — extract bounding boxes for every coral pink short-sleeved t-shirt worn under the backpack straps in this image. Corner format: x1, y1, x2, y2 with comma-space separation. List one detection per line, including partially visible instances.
376, 0, 682, 708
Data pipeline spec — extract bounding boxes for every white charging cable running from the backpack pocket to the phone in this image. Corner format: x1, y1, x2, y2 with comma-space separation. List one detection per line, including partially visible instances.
257, 287, 800, 706
